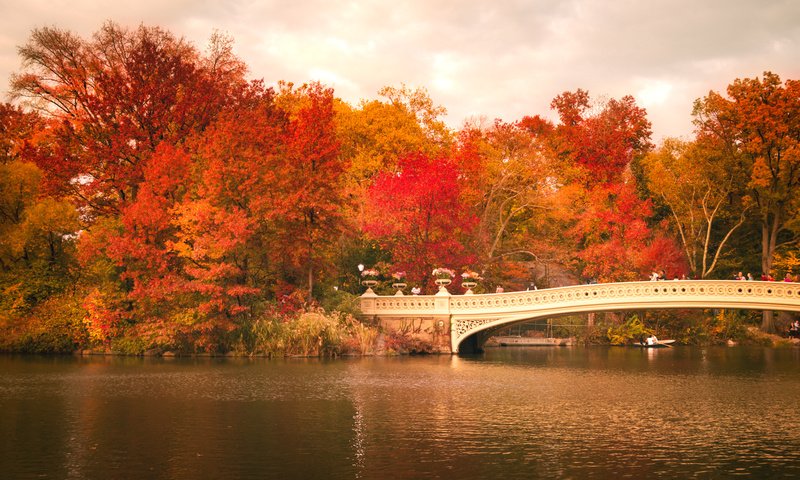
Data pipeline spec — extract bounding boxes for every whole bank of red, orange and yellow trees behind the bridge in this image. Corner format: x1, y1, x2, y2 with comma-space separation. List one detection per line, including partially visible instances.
0, 23, 800, 355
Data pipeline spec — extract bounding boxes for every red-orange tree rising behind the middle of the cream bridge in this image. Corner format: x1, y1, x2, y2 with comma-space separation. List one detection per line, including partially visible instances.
536, 89, 668, 281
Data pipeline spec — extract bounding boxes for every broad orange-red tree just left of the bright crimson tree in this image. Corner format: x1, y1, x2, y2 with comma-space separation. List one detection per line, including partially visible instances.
175, 84, 346, 313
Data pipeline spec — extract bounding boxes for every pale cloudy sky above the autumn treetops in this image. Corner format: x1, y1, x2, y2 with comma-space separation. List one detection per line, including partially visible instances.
0, 0, 800, 142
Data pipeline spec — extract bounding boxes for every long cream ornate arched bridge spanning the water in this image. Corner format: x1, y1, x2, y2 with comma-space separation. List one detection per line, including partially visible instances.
360, 280, 800, 353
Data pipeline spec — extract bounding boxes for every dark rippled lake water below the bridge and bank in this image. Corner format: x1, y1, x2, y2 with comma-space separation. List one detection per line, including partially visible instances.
0, 347, 800, 479
